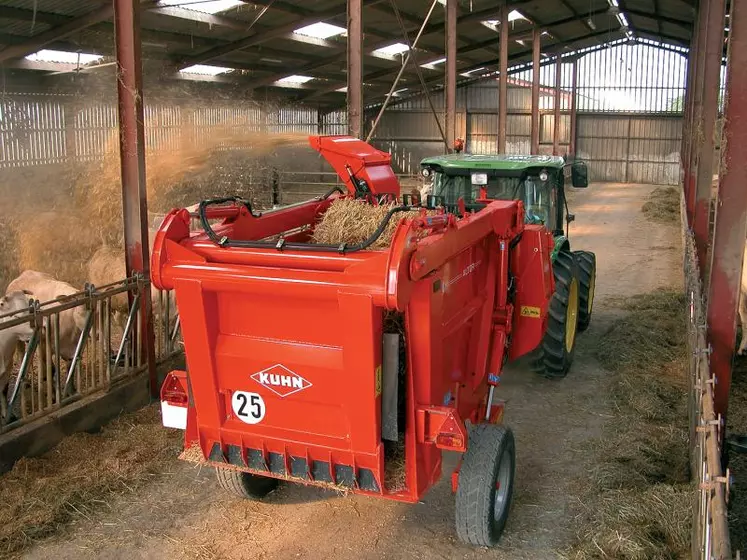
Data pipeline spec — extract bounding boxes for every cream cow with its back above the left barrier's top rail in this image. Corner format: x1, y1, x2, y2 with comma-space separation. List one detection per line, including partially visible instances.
6, 270, 86, 361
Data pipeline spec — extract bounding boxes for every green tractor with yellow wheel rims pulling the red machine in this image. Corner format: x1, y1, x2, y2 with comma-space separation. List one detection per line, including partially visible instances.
420, 153, 596, 378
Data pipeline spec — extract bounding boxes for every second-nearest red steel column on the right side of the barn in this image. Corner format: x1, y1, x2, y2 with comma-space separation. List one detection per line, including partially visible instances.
693, 0, 725, 274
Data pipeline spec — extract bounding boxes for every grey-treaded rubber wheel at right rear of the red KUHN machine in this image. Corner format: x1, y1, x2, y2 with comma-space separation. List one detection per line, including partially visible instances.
456, 424, 516, 546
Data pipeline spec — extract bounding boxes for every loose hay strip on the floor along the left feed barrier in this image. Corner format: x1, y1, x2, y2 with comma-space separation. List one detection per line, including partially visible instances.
0, 406, 183, 558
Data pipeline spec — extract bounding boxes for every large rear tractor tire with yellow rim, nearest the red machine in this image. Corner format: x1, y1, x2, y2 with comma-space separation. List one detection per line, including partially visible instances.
531, 251, 580, 378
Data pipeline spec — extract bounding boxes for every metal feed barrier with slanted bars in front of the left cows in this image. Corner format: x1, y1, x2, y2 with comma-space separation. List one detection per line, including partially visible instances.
0, 275, 181, 433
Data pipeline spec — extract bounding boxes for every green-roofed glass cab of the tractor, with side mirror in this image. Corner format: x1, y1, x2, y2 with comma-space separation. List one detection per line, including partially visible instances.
420, 153, 588, 233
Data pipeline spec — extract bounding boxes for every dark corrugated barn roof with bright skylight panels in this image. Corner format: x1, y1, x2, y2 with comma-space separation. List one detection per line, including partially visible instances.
0, 0, 694, 107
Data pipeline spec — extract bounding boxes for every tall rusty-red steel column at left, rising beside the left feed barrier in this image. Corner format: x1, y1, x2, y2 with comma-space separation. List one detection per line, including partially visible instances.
114, 0, 160, 398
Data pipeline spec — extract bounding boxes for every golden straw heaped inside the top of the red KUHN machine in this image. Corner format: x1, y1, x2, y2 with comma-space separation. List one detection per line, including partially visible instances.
312, 198, 419, 250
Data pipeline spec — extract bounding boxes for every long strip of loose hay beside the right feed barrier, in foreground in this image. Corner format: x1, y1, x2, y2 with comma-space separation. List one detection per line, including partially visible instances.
569, 290, 694, 560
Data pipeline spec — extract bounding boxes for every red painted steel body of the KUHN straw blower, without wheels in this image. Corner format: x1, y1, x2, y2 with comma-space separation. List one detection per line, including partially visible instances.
153, 138, 553, 502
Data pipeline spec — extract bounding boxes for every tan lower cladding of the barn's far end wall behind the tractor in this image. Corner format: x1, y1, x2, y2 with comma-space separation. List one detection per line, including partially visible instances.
367, 81, 682, 185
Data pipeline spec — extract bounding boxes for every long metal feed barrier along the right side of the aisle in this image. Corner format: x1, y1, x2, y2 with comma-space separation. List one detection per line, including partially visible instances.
682, 198, 732, 560
